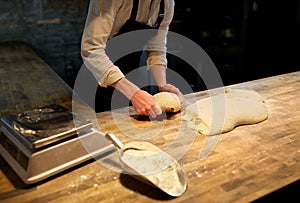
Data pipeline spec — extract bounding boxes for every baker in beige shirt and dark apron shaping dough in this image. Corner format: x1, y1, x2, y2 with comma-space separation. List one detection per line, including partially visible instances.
81, 0, 184, 118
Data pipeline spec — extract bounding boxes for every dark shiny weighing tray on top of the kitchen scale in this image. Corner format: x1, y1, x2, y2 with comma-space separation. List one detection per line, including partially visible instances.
1, 104, 92, 150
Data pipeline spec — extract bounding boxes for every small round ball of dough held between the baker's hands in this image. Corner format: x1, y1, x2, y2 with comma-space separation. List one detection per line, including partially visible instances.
153, 92, 181, 113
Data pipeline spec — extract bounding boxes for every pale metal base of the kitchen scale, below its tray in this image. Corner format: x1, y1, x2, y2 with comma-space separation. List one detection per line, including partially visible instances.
0, 126, 114, 184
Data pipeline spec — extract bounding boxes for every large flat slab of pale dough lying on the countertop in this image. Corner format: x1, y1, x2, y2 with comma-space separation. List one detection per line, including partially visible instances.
183, 88, 268, 135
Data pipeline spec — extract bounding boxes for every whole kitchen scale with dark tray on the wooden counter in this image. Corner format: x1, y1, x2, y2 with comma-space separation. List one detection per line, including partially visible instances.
0, 104, 114, 184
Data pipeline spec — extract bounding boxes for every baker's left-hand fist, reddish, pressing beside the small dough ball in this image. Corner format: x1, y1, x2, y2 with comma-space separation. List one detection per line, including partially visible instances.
131, 90, 162, 118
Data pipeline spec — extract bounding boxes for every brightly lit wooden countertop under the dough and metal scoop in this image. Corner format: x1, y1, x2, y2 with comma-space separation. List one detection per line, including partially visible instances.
0, 42, 300, 203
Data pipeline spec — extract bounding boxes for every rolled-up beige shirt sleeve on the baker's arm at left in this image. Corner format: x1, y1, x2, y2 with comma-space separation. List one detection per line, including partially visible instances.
81, 0, 124, 87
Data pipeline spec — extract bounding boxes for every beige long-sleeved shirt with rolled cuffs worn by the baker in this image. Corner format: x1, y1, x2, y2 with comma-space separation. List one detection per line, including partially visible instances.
81, 0, 175, 87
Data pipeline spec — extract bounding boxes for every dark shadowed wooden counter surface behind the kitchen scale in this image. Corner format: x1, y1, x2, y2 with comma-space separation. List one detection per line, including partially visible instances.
0, 42, 72, 119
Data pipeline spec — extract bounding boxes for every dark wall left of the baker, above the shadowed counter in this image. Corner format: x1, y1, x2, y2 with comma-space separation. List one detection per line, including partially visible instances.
0, 0, 89, 78
